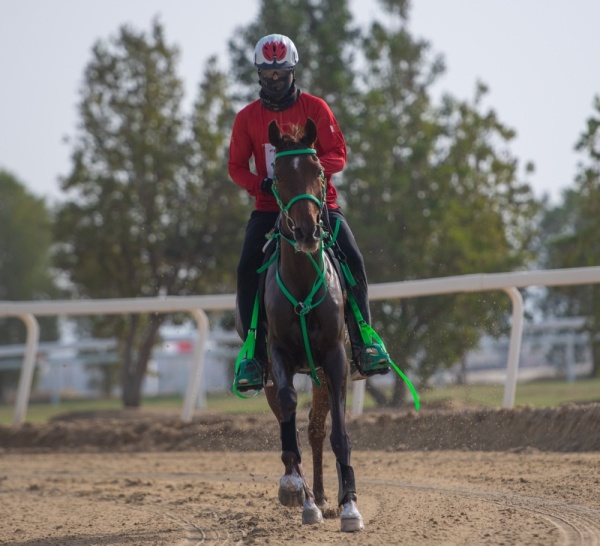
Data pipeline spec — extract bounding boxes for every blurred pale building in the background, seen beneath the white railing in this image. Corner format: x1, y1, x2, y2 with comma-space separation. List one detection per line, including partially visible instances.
0, 318, 592, 402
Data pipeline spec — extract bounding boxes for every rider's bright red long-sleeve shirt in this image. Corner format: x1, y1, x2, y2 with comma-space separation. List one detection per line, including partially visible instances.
229, 93, 346, 211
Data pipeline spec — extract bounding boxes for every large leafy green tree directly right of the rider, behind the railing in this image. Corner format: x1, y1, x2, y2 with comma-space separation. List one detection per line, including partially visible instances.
343, 0, 537, 404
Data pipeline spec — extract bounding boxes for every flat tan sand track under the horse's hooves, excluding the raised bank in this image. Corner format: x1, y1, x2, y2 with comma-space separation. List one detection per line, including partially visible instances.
0, 451, 600, 546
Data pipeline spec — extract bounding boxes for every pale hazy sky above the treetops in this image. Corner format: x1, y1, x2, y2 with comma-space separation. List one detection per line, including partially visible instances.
0, 0, 600, 203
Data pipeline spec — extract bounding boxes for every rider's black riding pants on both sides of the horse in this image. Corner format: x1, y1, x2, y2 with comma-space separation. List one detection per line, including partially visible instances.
237, 209, 371, 357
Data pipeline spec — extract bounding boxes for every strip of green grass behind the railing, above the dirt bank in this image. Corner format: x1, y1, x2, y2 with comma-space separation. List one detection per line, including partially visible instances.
0, 378, 600, 425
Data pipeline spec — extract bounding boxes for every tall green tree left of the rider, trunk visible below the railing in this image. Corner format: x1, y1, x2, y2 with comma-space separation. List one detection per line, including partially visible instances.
56, 21, 234, 407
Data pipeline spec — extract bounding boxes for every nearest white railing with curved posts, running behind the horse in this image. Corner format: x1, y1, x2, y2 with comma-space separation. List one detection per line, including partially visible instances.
0, 267, 600, 425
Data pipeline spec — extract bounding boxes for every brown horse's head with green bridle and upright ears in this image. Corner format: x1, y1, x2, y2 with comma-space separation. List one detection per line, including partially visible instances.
269, 118, 326, 252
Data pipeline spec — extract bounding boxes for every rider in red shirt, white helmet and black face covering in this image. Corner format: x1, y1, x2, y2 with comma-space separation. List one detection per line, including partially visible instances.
229, 34, 390, 391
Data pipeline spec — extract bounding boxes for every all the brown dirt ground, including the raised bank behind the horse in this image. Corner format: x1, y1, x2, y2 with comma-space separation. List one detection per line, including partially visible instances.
0, 404, 600, 546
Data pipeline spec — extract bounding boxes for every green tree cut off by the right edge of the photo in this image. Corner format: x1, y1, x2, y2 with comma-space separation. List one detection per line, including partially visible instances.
542, 96, 600, 377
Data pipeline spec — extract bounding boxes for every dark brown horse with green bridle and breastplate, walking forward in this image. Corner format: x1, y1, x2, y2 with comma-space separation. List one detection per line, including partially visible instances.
263, 118, 364, 532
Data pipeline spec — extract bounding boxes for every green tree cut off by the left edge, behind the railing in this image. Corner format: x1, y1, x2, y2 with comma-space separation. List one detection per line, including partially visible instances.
0, 170, 58, 400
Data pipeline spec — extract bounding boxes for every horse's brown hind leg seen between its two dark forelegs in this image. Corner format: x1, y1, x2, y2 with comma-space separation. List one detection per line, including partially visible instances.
308, 370, 329, 508
